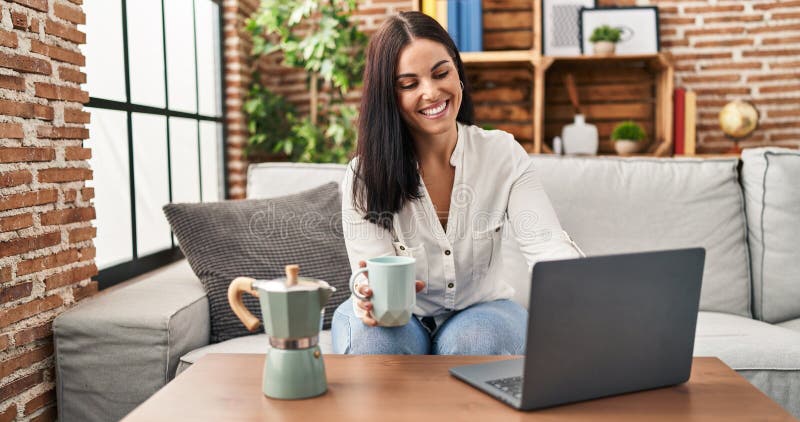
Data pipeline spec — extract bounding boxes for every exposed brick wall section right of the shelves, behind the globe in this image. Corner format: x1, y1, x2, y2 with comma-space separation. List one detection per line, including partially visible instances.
650, 0, 800, 152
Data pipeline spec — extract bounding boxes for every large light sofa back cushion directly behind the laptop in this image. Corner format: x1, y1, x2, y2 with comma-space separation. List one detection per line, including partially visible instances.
512, 155, 750, 316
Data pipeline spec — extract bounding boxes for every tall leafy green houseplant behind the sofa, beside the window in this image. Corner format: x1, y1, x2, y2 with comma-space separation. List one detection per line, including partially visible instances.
244, 0, 367, 163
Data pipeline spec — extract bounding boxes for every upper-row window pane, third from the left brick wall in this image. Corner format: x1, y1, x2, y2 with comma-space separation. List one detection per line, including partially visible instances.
164, 0, 197, 113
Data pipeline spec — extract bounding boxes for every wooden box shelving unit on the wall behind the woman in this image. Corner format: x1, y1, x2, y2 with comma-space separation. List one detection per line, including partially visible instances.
413, 0, 674, 156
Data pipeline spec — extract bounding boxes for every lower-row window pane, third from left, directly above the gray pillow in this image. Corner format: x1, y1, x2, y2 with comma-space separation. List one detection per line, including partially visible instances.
169, 117, 200, 202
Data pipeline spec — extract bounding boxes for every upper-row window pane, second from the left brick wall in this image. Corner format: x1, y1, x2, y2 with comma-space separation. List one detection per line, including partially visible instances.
127, 0, 166, 108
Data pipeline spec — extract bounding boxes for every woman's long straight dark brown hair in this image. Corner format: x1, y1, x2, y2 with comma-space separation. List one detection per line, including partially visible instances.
353, 12, 474, 229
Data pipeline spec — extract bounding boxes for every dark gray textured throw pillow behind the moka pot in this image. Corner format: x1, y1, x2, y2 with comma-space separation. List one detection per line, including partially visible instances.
164, 182, 350, 343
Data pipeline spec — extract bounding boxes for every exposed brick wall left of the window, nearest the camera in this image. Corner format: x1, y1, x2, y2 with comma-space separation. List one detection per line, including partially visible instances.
0, 0, 97, 421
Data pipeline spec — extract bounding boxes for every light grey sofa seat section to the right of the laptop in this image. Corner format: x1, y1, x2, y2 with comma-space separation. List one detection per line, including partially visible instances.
694, 312, 800, 417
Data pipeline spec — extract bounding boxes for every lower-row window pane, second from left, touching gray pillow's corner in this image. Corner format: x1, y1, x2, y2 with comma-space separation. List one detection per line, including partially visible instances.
131, 113, 172, 257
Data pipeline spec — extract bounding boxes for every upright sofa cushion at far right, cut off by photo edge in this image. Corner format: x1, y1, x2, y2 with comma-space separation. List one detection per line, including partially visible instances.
742, 148, 800, 322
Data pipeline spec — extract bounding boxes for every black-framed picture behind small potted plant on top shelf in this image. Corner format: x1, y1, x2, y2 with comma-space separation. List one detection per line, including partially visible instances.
579, 7, 661, 54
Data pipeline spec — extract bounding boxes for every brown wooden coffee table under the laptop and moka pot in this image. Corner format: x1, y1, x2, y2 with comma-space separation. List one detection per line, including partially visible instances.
124, 354, 794, 422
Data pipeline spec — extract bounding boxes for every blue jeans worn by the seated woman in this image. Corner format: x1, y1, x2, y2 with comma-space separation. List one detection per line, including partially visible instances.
331, 298, 528, 355
